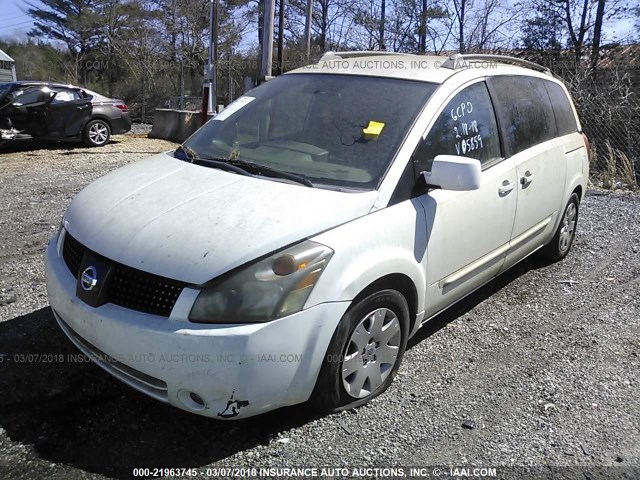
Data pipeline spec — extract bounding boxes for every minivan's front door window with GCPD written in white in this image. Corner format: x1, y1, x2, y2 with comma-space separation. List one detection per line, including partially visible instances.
413, 82, 502, 175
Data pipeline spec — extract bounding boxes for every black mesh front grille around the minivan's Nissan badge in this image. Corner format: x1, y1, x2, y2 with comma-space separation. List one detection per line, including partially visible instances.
62, 232, 186, 317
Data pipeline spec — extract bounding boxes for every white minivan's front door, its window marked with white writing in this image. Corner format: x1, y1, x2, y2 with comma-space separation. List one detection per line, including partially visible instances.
414, 81, 518, 318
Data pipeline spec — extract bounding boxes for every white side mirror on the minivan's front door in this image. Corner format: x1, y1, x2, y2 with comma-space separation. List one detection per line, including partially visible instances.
422, 155, 482, 191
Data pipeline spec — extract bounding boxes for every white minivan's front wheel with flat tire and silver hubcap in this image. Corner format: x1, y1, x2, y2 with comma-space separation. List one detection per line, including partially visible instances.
310, 290, 409, 413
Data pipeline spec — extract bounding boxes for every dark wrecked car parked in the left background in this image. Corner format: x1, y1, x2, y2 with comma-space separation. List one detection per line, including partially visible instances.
0, 81, 131, 147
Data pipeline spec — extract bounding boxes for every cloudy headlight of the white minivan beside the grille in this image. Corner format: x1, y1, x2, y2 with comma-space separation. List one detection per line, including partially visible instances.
189, 240, 333, 323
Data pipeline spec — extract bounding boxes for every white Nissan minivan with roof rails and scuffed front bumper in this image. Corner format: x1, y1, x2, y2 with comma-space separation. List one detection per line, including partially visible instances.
46, 52, 588, 419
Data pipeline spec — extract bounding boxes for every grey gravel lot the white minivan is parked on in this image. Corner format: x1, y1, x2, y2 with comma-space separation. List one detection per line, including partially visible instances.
0, 135, 640, 479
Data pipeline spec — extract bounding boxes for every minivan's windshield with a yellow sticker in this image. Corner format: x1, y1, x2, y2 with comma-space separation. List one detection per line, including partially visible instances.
185, 74, 436, 190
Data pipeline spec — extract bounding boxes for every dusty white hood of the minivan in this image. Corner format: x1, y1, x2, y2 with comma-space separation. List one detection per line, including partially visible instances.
65, 154, 377, 284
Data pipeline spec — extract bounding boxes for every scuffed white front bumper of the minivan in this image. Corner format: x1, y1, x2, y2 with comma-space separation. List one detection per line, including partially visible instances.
45, 237, 349, 419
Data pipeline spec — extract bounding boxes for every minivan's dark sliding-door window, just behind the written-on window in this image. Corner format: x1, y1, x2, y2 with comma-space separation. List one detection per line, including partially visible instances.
490, 76, 558, 155
